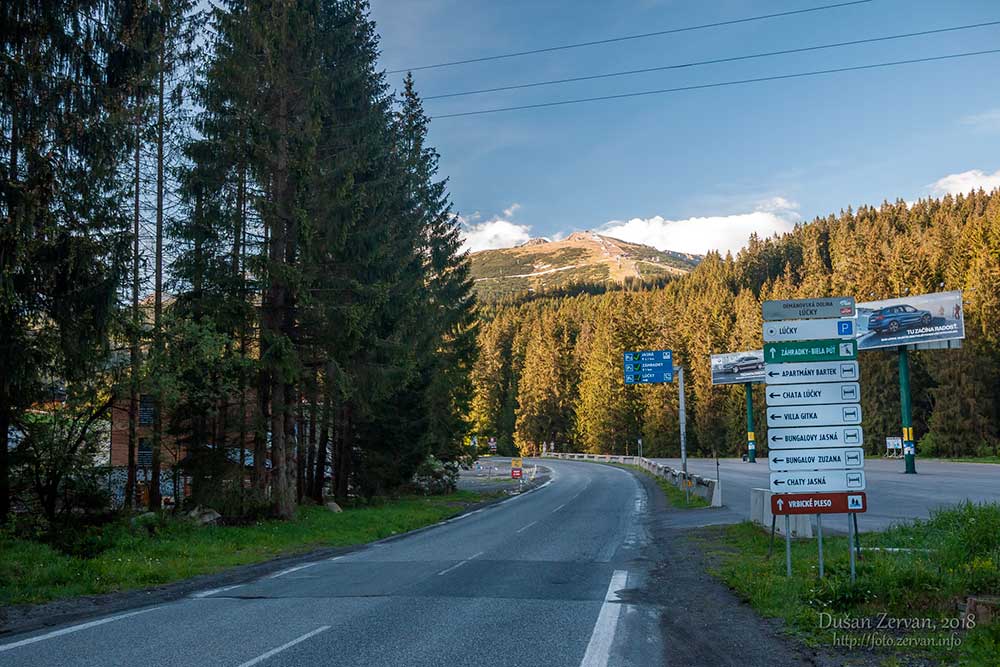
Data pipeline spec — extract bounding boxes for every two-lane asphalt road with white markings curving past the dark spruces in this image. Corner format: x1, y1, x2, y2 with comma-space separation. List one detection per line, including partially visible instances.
0, 461, 664, 667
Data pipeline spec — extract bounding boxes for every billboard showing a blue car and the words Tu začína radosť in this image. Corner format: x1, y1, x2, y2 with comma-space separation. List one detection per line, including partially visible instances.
858, 291, 965, 350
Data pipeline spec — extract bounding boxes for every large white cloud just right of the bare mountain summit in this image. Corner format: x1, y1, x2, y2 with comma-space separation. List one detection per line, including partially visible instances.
601, 197, 801, 255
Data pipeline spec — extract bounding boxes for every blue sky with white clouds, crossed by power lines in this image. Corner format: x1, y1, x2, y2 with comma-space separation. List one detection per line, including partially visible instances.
372, 0, 1000, 253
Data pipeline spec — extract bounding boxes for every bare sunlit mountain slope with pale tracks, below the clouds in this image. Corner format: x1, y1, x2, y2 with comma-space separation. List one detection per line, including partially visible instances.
471, 232, 701, 299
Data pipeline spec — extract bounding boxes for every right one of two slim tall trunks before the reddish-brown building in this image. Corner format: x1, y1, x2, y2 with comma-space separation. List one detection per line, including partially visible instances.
149, 54, 166, 511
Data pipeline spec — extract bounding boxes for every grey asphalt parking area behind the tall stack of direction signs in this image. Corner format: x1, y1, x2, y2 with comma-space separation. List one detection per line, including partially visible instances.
654, 457, 1000, 532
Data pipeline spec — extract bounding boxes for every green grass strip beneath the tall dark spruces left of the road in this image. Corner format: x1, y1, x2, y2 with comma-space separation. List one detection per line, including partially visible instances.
0, 491, 489, 605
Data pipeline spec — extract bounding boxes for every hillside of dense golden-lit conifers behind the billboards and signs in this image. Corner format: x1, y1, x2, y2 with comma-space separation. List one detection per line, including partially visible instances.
472, 191, 1000, 456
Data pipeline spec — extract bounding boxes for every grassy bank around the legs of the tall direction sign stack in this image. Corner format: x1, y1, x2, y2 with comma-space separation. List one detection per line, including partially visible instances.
697, 503, 1000, 667
